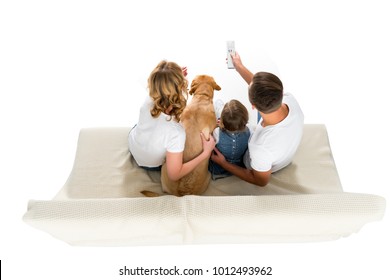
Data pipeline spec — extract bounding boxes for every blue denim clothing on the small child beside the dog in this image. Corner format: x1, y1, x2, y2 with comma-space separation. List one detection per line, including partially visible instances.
209, 128, 250, 180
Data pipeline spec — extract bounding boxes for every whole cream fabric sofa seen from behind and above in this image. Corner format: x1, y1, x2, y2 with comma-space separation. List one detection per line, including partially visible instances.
23, 124, 385, 246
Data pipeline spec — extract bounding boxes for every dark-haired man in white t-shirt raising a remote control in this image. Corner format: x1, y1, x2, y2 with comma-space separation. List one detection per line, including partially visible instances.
211, 52, 304, 187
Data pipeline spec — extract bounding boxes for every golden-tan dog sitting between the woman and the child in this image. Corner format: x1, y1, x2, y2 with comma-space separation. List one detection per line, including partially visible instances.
142, 75, 221, 196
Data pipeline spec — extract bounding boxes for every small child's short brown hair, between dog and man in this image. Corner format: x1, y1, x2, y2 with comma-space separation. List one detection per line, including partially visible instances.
219, 99, 249, 132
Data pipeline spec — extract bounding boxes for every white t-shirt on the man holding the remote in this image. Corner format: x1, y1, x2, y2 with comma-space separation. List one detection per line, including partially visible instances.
244, 93, 304, 172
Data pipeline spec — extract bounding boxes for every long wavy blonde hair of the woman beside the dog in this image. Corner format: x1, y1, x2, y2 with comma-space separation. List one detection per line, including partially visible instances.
148, 60, 188, 122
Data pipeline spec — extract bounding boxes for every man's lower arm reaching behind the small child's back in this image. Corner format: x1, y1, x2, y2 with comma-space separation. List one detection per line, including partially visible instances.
211, 148, 271, 187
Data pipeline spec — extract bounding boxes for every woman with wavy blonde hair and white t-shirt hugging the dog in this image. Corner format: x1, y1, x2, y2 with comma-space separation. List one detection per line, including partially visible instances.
128, 60, 215, 181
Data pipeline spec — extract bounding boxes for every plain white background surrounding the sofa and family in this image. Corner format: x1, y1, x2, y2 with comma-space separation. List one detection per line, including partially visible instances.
0, 0, 390, 280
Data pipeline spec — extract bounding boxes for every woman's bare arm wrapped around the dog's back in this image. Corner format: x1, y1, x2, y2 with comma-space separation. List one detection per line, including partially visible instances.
166, 133, 215, 181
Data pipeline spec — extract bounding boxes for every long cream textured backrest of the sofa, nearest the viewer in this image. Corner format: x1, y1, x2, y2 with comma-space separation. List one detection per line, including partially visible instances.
24, 193, 385, 246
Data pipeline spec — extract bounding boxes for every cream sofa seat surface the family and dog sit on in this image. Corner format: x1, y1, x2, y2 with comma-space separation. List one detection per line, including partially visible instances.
56, 124, 342, 199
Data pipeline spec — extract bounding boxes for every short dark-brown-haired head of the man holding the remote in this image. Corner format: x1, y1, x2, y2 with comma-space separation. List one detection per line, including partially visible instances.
249, 72, 283, 114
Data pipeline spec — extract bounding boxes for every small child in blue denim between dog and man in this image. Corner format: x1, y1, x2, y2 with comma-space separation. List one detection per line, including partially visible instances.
209, 99, 250, 180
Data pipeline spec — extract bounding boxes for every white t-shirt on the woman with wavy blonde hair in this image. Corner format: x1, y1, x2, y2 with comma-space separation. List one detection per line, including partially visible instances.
128, 97, 186, 167
